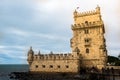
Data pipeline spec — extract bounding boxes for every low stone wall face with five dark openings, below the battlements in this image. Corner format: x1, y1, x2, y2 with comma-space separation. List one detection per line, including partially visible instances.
30, 59, 80, 73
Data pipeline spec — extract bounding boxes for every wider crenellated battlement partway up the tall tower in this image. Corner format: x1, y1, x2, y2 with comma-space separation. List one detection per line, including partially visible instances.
71, 21, 103, 30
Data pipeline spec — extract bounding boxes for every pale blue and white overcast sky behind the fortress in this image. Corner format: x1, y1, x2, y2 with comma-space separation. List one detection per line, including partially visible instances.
0, 0, 120, 64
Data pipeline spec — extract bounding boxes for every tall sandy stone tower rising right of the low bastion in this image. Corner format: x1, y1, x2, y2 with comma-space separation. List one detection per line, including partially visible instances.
71, 6, 107, 69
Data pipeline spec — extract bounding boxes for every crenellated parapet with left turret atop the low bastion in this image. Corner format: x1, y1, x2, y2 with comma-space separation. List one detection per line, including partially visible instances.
28, 47, 80, 62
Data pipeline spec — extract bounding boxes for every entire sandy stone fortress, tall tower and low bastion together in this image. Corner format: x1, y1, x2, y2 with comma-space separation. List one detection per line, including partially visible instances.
27, 6, 107, 73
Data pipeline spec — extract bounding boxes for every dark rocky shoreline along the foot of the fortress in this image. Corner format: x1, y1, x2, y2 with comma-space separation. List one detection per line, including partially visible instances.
9, 72, 120, 80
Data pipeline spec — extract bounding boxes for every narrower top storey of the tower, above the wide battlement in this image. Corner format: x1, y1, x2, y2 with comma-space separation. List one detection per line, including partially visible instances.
73, 6, 102, 26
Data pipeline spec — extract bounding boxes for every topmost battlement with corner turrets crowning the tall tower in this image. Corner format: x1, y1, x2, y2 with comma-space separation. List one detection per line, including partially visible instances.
74, 6, 100, 18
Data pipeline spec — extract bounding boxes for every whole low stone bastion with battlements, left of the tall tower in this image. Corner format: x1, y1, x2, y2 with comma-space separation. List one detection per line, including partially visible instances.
28, 48, 80, 73
